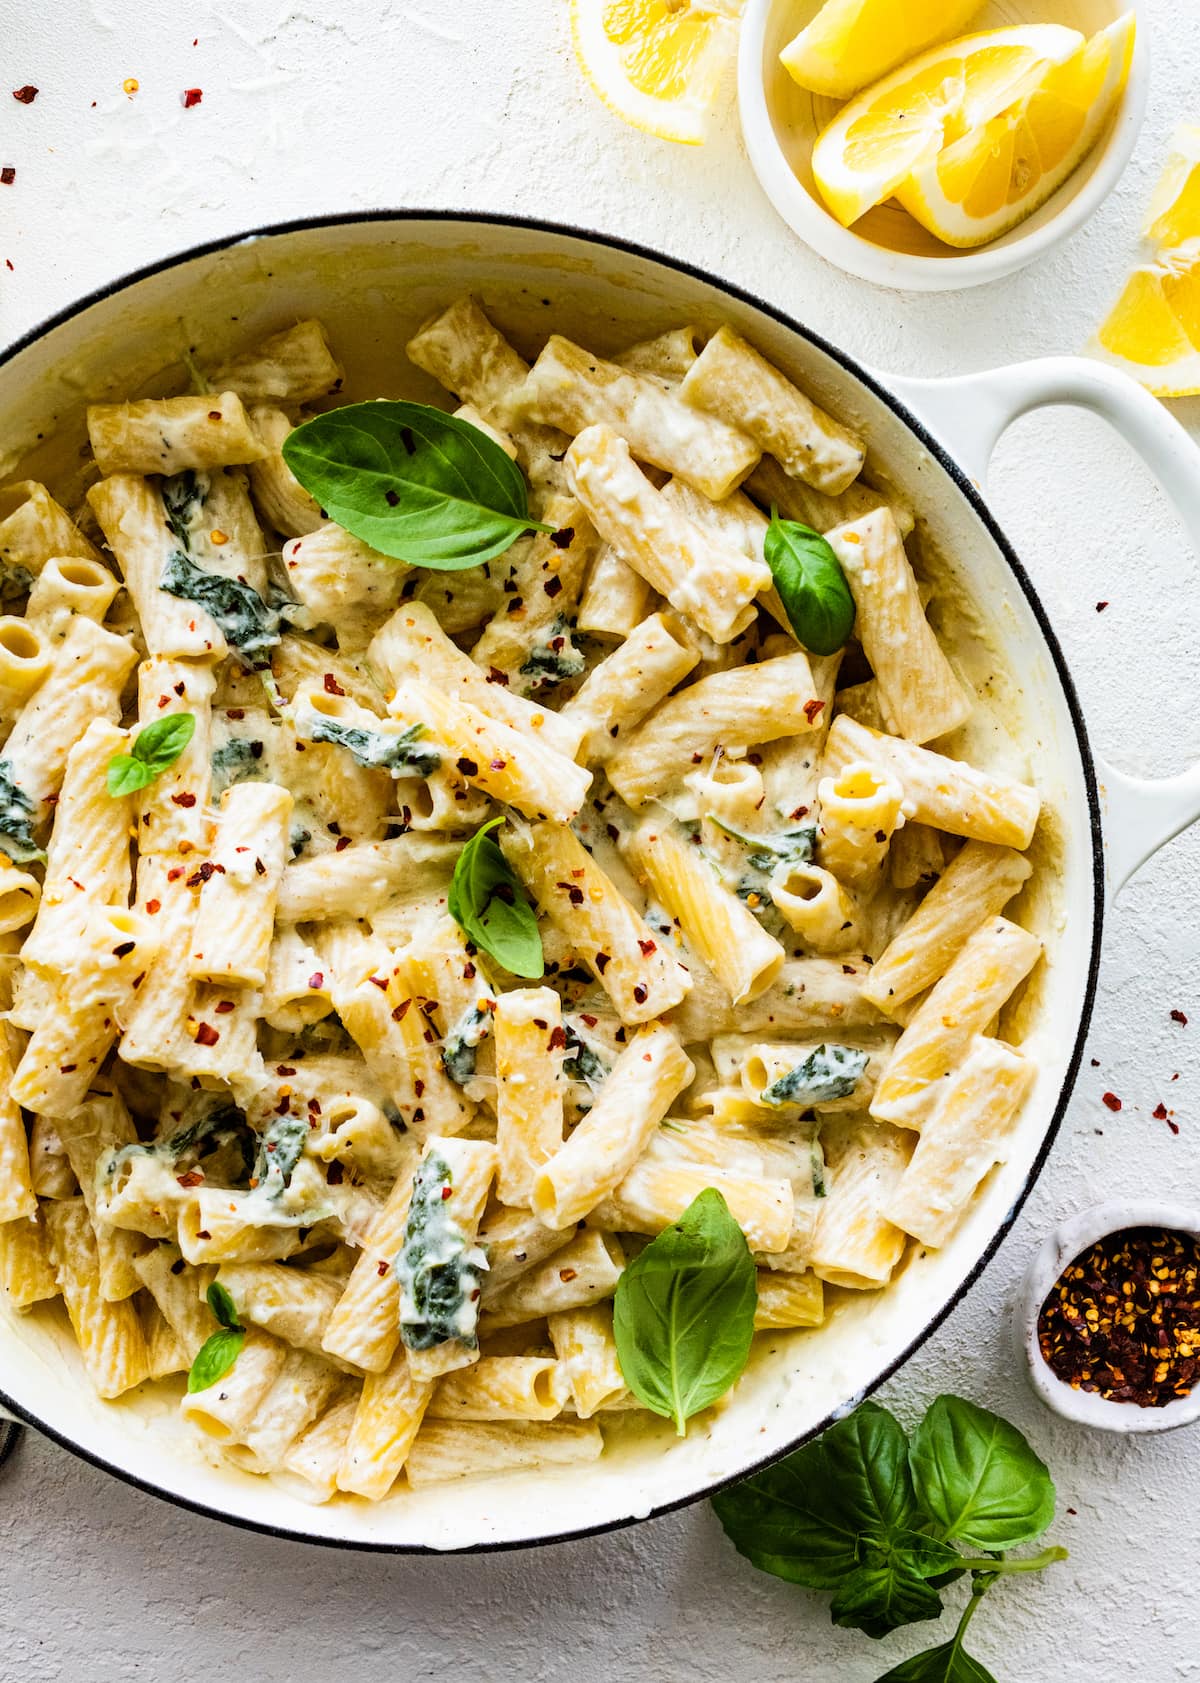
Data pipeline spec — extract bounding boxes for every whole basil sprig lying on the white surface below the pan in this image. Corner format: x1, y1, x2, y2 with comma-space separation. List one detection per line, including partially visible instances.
712, 1397, 1067, 1683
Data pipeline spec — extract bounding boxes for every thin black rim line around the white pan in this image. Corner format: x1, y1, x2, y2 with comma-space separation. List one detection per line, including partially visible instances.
0, 209, 1104, 1555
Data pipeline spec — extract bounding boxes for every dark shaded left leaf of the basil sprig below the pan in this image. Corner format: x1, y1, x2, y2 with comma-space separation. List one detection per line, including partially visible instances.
712, 1402, 921, 1589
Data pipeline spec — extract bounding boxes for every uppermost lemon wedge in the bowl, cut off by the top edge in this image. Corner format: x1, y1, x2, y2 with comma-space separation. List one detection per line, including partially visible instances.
779, 0, 983, 99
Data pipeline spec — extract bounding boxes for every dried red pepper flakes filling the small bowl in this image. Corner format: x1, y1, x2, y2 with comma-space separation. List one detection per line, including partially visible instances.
1037, 1227, 1200, 1409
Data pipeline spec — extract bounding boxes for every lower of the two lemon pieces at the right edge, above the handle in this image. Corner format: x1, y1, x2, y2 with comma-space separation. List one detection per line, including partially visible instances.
1089, 239, 1200, 397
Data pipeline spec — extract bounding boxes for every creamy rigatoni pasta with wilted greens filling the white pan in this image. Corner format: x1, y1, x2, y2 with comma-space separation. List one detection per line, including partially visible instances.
0, 298, 1042, 1501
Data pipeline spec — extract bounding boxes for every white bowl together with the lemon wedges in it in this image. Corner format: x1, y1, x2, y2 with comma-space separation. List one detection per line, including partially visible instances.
737, 0, 1148, 291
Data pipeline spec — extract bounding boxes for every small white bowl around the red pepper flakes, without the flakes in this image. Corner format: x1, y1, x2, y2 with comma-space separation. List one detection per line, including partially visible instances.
1015, 1200, 1200, 1432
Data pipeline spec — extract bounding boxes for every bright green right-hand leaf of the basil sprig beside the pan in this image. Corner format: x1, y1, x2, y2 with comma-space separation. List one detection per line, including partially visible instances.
909, 1397, 1055, 1552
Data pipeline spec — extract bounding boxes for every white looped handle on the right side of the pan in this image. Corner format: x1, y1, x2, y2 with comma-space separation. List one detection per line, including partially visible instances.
885, 357, 1200, 904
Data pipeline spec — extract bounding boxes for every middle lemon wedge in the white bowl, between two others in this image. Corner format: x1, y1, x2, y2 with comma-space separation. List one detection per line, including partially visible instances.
813, 24, 1084, 227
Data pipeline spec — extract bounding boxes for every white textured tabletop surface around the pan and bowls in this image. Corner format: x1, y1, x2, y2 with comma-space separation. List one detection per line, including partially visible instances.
0, 0, 1200, 1683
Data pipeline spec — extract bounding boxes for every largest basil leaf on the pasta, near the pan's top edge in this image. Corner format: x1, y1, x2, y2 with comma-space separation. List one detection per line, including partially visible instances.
283, 401, 550, 572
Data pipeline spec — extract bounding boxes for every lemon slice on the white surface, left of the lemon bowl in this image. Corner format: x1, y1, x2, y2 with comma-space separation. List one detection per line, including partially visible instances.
571, 0, 741, 146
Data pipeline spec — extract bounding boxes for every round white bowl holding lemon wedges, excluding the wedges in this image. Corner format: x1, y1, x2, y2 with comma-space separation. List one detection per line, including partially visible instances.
737, 0, 1150, 293
